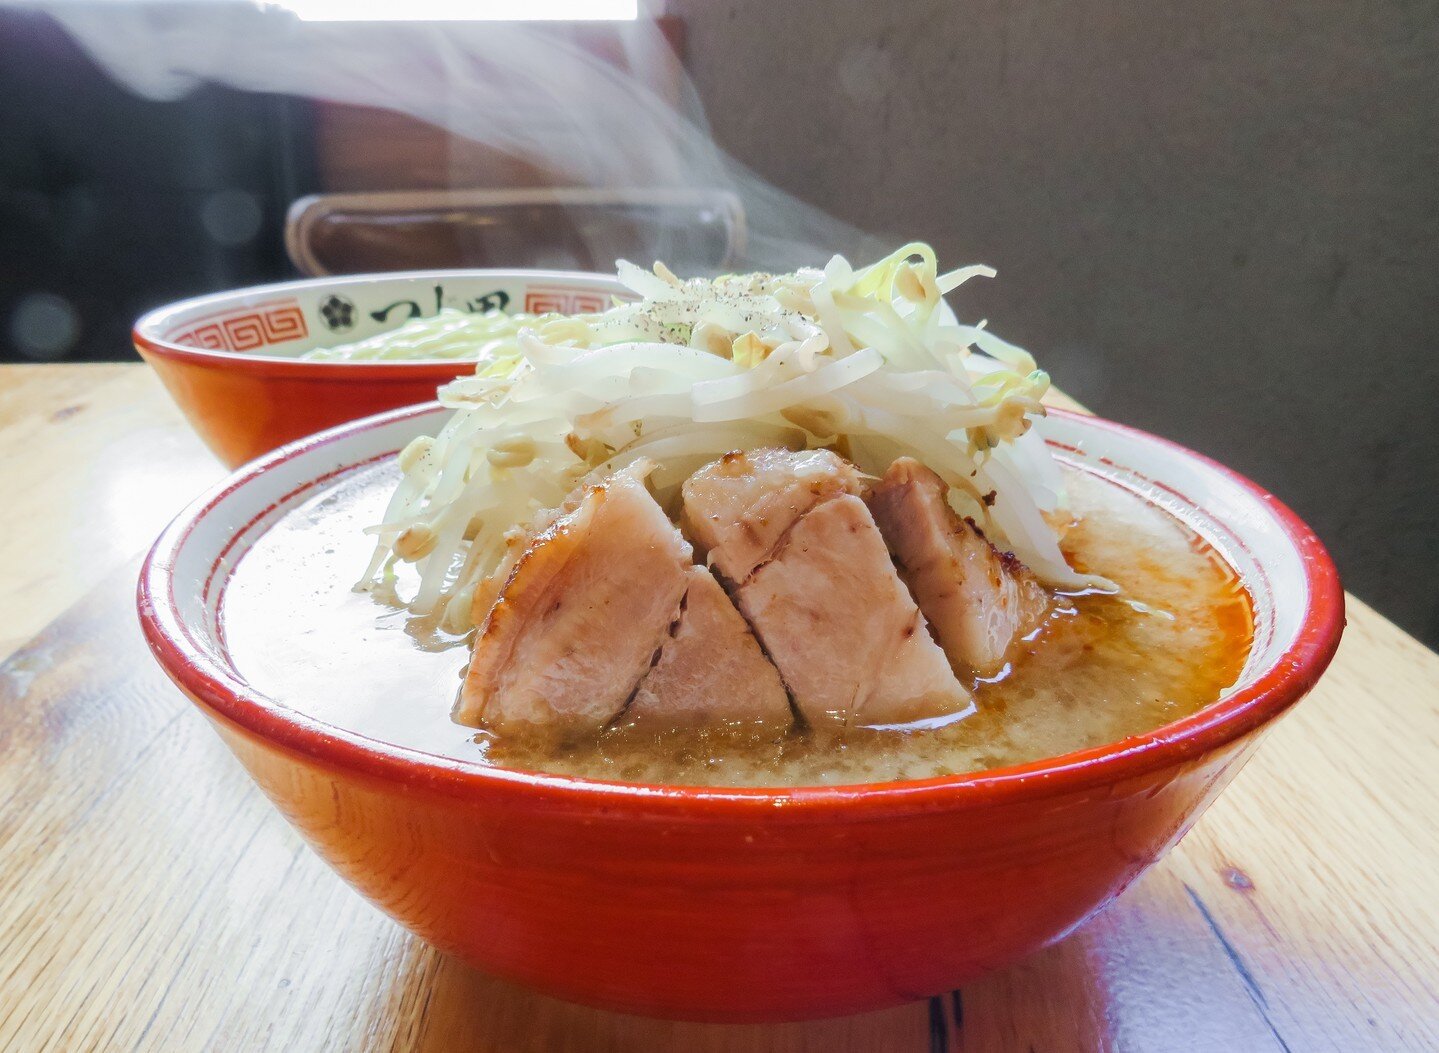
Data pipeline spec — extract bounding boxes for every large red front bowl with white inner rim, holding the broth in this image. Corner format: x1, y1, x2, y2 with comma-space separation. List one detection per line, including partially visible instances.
140, 406, 1343, 1020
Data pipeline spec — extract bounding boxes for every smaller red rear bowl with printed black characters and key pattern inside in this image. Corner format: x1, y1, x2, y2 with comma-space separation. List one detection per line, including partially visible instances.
134, 270, 627, 468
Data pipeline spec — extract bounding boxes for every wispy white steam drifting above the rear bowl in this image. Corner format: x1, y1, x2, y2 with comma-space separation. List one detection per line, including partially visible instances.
39, 0, 881, 272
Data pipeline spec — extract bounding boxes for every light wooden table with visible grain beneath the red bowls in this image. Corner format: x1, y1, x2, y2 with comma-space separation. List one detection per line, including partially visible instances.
0, 365, 1439, 1053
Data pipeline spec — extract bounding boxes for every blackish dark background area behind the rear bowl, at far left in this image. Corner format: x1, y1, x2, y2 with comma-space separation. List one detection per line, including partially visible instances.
0, 10, 312, 361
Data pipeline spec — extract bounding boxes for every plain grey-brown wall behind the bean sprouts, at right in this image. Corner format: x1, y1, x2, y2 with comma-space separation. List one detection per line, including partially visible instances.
669, 0, 1439, 644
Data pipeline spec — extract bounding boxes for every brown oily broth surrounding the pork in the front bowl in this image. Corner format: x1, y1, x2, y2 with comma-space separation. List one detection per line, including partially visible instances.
222, 466, 1252, 785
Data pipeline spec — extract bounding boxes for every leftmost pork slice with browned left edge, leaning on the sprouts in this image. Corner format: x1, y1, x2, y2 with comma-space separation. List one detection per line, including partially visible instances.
455, 468, 692, 738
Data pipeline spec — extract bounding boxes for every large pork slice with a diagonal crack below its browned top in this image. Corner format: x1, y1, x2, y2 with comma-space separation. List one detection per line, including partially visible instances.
684, 450, 973, 726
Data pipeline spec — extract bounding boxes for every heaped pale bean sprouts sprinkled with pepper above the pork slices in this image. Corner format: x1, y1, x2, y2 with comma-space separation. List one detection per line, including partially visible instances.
358, 243, 1108, 632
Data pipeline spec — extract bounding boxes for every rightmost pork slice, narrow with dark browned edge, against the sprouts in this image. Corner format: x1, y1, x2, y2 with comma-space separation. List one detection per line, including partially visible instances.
869, 457, 1049, 676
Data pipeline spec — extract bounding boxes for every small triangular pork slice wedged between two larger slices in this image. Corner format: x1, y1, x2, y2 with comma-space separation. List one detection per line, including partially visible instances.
623, 567, 794, 731
